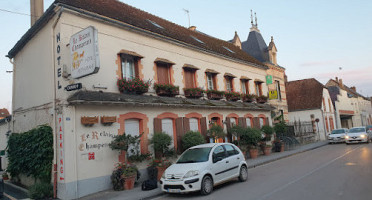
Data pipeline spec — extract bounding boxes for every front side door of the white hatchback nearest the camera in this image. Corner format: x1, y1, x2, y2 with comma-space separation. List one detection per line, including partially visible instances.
211, 145, 228, 183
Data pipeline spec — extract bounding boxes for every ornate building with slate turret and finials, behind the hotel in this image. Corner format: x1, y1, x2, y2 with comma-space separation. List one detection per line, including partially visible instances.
230, 14, 289, 122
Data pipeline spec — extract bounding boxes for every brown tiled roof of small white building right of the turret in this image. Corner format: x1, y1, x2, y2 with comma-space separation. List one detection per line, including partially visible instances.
285, 78, 324, 112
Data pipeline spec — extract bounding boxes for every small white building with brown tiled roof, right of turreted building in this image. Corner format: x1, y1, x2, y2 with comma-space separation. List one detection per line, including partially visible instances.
286, 78, 336, 140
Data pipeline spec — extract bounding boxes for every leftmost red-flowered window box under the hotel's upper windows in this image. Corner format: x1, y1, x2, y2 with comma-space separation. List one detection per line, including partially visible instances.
117, 78, 151, 94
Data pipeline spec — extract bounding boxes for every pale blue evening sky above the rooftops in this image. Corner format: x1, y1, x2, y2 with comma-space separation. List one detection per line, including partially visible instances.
0, 0, 372, 110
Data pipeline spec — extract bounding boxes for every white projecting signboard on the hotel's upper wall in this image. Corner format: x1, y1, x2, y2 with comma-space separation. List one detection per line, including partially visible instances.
70, 26, 100, 78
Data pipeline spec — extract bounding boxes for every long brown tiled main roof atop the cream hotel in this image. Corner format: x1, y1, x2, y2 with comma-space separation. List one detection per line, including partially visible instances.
8, 0, 267, 69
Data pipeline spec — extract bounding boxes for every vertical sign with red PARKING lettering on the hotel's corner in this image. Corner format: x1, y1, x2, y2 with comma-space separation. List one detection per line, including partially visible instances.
57, 114, 65, 181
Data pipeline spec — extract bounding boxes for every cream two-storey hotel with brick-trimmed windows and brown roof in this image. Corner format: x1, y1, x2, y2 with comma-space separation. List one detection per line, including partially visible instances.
8, 0, 276, 199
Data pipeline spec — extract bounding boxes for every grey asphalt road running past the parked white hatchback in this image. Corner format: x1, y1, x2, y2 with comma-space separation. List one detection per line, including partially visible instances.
156, 143, 372, 200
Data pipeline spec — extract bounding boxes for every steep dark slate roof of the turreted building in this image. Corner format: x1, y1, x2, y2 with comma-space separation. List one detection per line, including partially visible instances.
242, 31, 270, 62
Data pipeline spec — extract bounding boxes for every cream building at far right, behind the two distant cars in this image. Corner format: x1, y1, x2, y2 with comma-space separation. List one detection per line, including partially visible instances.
326, 77, 372, 128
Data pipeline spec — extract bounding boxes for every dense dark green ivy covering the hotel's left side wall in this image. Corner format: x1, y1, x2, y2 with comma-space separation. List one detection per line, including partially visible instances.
7, 125, 53, 182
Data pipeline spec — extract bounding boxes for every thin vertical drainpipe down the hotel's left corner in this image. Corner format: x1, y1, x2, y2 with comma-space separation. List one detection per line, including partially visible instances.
52, 5, 63, 198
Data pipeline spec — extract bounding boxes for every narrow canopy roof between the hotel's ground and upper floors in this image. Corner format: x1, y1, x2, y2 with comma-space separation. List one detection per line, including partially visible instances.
67, 90, 273, 111
